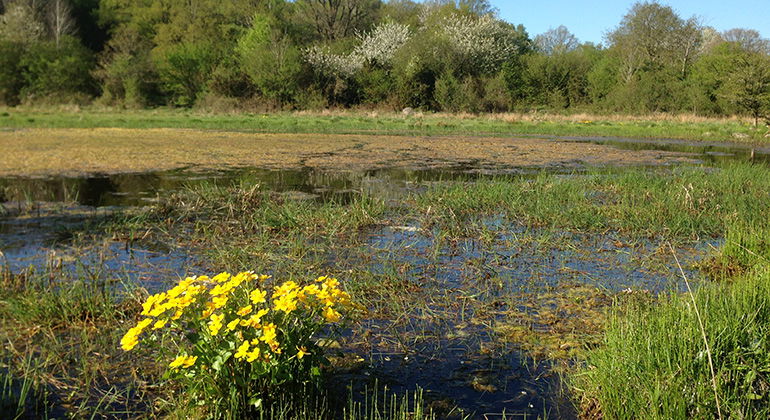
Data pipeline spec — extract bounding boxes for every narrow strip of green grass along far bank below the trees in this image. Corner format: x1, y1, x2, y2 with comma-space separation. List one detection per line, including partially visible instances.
0, 107, 768, 143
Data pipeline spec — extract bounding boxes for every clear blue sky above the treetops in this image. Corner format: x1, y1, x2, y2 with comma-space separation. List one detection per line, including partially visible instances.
490, 0, 770, 43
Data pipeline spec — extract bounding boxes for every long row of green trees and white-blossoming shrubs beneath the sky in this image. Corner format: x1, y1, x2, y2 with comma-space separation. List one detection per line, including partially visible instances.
0, 0, 770, 119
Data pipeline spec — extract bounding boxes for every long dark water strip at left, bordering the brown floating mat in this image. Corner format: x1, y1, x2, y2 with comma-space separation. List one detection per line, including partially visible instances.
0, 166, 500, 207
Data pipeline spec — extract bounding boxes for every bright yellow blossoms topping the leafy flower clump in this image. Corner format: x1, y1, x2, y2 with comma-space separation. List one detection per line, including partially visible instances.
120, 272, 355, 369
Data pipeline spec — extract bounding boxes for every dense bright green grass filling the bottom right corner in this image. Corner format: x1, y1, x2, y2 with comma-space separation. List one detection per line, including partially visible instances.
572, 223, 770, 419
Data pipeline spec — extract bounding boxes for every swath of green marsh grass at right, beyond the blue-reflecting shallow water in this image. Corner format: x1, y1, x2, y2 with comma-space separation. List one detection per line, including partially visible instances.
416, 164, 770, 239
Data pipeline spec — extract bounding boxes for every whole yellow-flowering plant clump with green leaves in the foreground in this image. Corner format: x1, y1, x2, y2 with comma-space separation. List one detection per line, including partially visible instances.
120, 272, 359, 418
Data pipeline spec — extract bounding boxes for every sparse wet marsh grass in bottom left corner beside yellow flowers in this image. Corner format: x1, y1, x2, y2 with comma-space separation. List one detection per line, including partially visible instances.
0, 267, 166, 418
